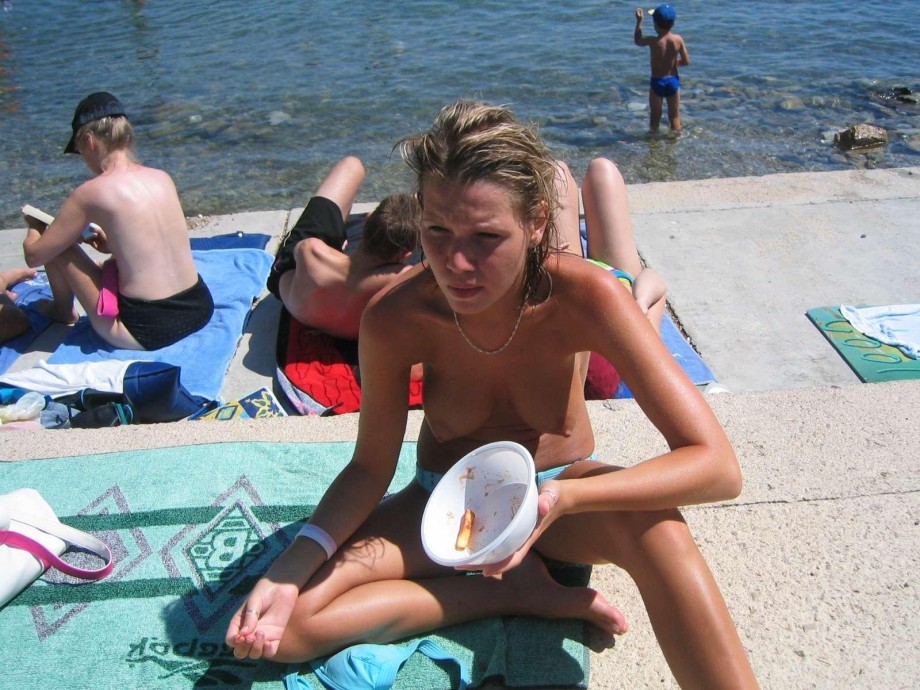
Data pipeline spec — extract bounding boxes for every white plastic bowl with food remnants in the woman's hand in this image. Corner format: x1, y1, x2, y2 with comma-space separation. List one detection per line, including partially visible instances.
422, 441, 537, 567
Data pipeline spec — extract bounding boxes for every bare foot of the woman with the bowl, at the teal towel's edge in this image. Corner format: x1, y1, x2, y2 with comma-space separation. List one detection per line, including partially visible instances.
501, 553, 629, 635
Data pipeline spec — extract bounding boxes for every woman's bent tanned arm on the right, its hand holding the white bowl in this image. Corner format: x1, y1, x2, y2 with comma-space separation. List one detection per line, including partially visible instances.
474, 259, 741, 575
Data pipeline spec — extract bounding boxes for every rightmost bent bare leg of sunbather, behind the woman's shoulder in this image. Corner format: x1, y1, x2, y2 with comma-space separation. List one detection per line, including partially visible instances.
582, 158, 666, 330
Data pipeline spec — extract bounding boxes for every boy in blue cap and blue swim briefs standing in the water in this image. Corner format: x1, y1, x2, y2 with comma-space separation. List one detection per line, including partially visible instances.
633, 5, 690, 130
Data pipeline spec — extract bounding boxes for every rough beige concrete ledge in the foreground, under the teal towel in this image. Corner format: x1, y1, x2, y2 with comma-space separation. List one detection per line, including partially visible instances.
0, 381, 920, 690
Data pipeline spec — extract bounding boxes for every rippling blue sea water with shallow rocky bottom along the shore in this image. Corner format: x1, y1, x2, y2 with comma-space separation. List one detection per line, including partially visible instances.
0, 0, 920, 228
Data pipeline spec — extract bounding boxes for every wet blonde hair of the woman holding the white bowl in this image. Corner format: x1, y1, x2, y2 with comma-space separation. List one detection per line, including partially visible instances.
399, 101, 559, 298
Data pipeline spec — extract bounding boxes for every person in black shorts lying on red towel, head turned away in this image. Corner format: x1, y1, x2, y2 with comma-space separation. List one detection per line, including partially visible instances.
267, 156, 421, 340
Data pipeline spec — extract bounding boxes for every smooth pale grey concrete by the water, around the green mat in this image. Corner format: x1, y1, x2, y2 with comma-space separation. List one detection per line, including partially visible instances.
629, 169, 920, 391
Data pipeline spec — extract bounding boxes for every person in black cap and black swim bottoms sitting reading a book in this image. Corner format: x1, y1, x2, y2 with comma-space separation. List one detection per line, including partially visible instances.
22, 91, 214, 350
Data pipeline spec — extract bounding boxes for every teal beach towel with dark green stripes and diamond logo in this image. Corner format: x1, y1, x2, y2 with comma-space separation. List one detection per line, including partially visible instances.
0, 443, 589, 690
